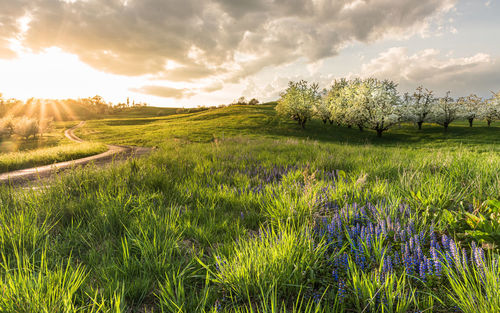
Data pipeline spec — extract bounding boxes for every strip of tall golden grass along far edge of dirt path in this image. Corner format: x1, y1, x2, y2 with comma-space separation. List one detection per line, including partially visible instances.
0, 142, 107, 173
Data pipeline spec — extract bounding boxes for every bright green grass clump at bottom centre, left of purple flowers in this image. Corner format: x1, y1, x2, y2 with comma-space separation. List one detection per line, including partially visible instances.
214, 226, 325, 301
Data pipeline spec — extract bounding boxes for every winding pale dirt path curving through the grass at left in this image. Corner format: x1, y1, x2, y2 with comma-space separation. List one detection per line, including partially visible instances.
0, 122, 152, 185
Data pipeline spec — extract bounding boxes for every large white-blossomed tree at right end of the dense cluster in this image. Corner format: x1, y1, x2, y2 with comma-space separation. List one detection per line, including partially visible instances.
348, 78, 401, 137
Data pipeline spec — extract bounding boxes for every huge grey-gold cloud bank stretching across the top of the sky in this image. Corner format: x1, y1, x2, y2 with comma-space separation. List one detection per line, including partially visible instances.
0, 0, 456, 82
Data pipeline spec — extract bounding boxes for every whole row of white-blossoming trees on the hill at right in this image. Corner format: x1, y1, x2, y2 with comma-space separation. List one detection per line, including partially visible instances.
276, 78, 500, 137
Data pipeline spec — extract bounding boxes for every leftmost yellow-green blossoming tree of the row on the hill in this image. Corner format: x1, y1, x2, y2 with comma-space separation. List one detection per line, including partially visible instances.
276, 80, 321, 128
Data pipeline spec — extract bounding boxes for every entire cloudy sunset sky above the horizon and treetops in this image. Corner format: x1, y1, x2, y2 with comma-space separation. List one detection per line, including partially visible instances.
0, 0, 500, 107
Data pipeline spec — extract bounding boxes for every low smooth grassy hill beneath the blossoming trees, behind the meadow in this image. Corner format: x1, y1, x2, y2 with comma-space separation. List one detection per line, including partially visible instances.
77, 103, 500, 151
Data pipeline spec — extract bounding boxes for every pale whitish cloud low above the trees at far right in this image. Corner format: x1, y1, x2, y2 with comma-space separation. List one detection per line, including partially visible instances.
356, 47, 500, 96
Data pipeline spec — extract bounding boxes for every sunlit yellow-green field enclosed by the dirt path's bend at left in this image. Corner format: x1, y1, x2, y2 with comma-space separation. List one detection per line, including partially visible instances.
0, 122, 107, 173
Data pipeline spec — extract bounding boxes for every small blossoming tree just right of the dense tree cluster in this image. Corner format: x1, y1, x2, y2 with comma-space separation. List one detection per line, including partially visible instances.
404, 86, 434, 130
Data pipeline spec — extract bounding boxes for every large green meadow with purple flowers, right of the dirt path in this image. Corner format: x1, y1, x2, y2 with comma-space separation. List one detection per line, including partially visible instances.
0, 104, 500, 312
